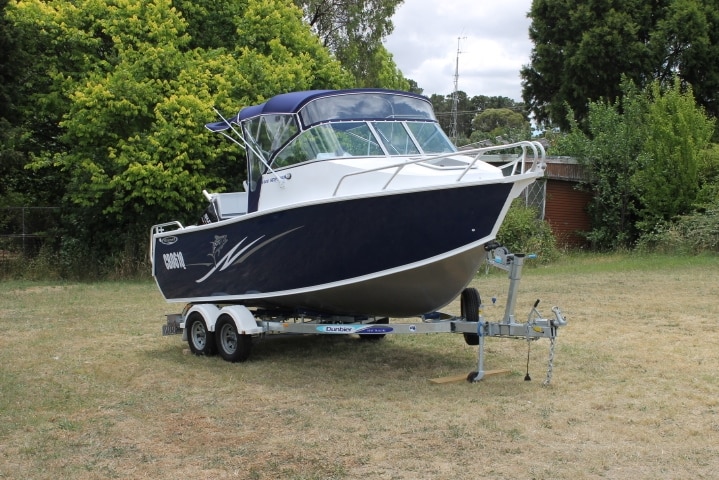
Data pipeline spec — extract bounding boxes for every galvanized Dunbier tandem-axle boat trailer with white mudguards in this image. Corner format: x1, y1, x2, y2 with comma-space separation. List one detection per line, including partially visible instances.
162, 246, 567, 385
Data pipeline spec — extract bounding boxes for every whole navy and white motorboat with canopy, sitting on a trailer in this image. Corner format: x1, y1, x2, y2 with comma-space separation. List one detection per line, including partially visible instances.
150, 89, 545, 318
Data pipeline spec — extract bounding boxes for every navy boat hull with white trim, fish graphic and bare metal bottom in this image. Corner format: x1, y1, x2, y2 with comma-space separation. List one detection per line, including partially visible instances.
153, 183, 513, 317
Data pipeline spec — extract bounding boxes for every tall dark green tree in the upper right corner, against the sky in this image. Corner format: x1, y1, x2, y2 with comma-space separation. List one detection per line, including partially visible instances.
521, 0, 719, 129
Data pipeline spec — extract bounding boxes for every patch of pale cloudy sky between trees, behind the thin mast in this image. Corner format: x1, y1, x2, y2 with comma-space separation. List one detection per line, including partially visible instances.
385, 0, 532, 101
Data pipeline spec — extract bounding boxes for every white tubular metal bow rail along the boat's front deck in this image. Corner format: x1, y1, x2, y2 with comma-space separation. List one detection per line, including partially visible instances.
332, 141, 546, 197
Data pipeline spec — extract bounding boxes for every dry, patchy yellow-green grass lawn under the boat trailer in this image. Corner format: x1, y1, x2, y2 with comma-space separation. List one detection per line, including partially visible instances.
0, 255, 719, 480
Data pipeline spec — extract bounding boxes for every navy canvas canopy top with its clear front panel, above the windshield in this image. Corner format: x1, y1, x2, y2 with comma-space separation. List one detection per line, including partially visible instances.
207, 88, 436, 132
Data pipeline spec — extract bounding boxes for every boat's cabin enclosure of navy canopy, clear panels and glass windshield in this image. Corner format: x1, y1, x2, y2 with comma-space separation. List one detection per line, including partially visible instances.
207, 89, 456, 216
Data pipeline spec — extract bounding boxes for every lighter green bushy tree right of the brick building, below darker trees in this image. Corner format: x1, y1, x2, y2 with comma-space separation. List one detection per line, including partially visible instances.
550, 79, 713, 249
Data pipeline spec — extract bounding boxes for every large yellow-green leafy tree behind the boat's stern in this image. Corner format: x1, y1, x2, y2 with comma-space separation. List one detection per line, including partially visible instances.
7, 0, 352, 272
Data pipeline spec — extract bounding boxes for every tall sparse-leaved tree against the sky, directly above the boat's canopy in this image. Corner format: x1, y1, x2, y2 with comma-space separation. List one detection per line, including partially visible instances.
295, 0, 410, 90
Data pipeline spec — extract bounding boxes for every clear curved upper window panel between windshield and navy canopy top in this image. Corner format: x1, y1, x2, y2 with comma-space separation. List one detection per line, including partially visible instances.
300, 93, 435, 126
